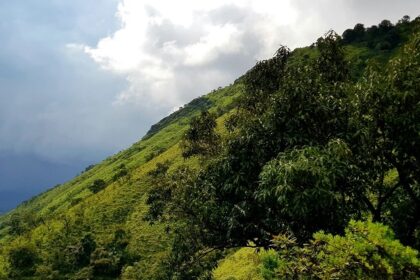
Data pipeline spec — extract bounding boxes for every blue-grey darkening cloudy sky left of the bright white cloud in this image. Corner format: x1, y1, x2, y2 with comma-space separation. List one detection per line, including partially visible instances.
0, 0, 165, 212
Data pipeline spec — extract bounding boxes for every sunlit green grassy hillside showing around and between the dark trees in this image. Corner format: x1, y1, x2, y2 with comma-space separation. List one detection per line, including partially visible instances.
0, 16, 419, 279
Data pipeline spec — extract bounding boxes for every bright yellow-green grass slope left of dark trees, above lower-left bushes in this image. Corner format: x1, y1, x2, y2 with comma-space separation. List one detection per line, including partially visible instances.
0, 83, 242, 279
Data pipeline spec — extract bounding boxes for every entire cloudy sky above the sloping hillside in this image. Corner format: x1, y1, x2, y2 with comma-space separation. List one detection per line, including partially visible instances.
0, 0, 420, 212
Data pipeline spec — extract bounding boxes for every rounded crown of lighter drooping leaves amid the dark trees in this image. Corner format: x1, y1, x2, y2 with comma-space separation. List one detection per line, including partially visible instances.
255, 140, 363, 240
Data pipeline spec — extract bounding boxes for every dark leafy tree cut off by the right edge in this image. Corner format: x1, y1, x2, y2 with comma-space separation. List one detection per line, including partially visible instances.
349, 32, 420, 248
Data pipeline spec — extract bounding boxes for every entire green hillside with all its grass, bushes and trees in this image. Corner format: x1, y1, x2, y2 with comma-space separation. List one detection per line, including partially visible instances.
0, 17, 420, 279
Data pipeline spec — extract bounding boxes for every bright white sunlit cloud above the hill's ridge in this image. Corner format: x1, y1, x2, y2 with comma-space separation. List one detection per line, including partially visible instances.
85, 0, 297, 108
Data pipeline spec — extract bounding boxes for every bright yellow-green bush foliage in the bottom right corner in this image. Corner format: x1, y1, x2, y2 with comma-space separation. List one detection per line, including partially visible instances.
262, 221, 420, 279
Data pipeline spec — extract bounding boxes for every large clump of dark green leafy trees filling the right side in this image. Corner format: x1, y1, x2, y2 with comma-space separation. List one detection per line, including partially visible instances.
145, 28, 420, 278
